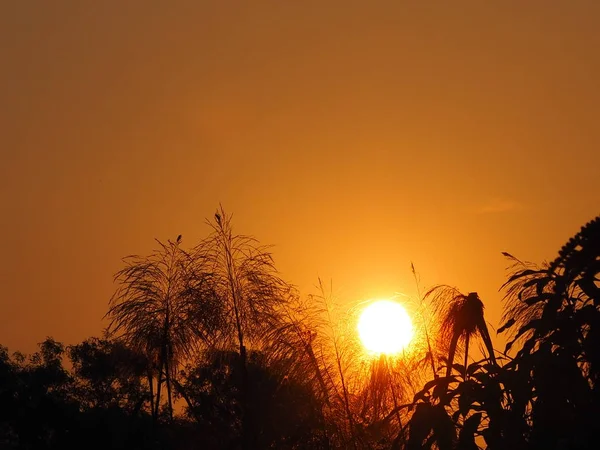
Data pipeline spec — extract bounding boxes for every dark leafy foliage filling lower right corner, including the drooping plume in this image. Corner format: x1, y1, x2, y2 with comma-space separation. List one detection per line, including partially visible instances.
399, 214, 600, 449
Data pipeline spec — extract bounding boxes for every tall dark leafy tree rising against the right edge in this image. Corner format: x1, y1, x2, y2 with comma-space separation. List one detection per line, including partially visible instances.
499, 217, 600, 448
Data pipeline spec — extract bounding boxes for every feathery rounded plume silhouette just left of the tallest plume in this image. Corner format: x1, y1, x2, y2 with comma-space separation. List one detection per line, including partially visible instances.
107, 238, 222, 418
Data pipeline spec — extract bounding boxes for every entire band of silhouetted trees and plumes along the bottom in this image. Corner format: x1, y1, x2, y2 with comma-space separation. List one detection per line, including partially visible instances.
0, 209, 600, 450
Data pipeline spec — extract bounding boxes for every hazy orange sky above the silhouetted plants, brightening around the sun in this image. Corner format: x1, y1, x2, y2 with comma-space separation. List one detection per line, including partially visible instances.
0, 0, 600, 351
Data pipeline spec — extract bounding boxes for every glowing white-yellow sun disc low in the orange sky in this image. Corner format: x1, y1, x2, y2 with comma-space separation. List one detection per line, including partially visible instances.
358, 300, 413, 355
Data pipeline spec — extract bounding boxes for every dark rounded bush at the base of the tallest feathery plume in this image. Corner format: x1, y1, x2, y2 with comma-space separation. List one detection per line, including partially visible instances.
181, 351, 326, 449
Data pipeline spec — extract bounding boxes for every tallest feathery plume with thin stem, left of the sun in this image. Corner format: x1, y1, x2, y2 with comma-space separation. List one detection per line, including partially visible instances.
194, 206, 293, 448
